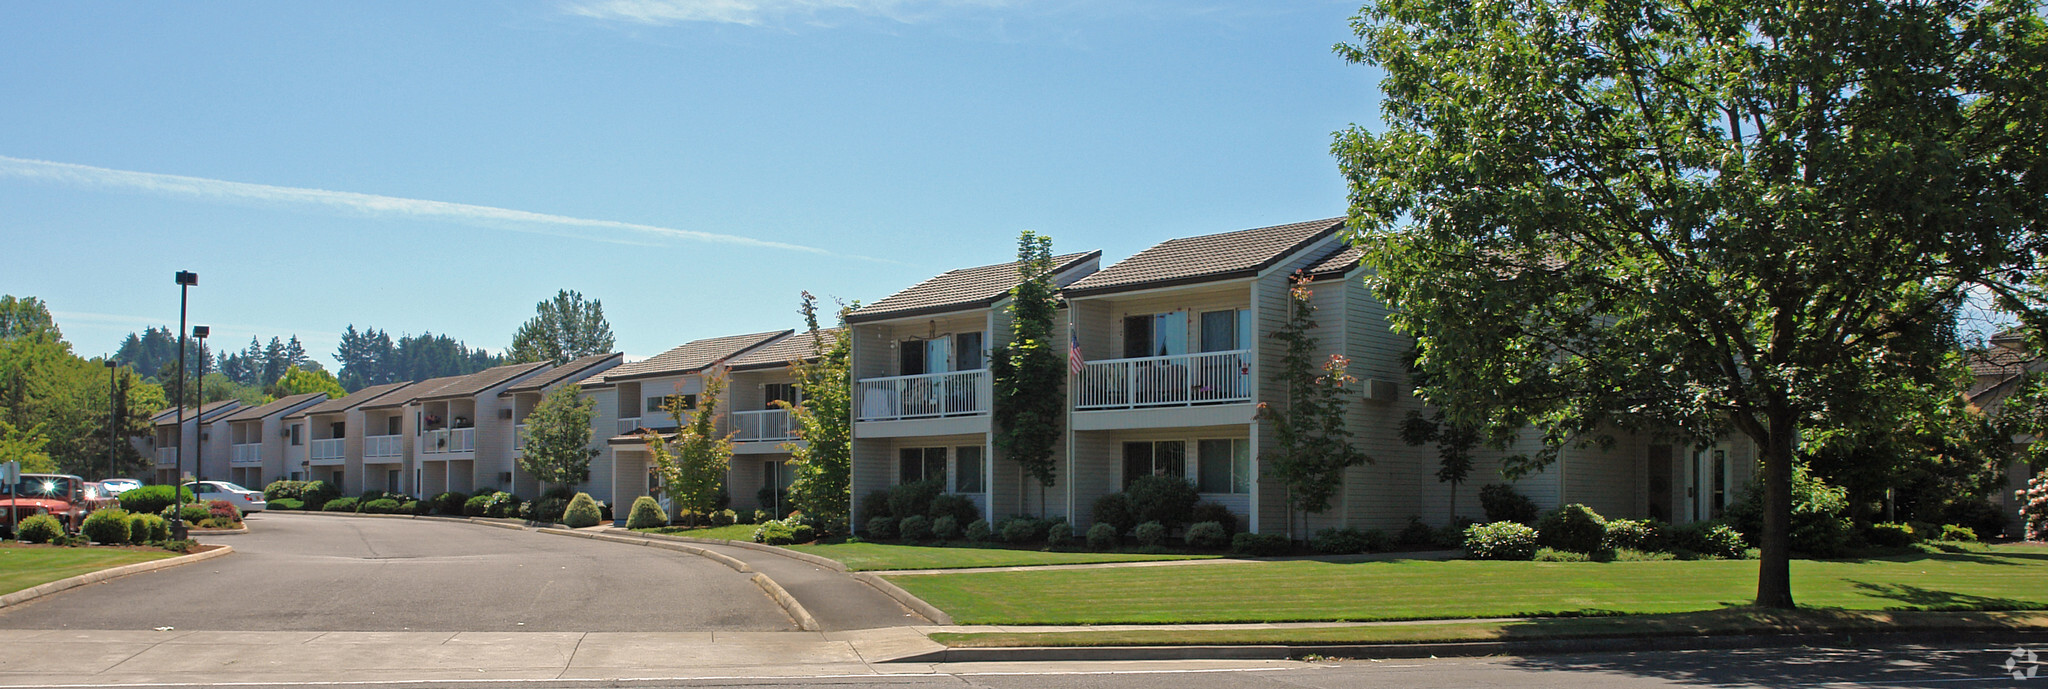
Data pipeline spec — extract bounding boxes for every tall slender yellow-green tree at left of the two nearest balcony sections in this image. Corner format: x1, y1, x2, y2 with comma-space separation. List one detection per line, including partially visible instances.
778, 291, 854, 533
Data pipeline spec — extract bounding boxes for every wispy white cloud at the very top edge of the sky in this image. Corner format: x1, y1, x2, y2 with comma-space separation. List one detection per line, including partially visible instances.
563, 0, 1012, 27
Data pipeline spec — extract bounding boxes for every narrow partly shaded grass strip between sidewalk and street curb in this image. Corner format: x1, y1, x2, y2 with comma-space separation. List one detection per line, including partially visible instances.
932, 607, 2048, 648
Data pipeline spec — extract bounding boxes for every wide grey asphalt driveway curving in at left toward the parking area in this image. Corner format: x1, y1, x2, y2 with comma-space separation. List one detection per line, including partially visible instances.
0, 515, 795, 632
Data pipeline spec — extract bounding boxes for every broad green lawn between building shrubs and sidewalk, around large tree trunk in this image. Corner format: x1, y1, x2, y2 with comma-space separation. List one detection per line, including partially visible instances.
891, 545, 2048, 625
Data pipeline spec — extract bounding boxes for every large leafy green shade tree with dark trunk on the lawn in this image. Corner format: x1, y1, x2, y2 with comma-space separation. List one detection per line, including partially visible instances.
1333, 0, 2048, 607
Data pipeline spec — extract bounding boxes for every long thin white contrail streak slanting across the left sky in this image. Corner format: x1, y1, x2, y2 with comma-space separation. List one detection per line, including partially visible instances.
0, 156, 874, 260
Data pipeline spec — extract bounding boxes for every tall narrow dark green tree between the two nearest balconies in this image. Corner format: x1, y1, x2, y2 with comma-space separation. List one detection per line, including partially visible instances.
989, 230, 1067, 515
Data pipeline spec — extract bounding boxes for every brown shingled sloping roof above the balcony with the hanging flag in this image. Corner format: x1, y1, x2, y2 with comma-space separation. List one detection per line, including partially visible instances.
1067, 217, 1343, 297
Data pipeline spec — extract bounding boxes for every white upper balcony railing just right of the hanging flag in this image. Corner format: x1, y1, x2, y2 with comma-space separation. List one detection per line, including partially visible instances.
1075, 349, 1253, 410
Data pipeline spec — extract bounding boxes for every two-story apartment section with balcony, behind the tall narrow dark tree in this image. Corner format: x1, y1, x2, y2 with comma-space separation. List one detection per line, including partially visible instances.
846, 252, 1102, 529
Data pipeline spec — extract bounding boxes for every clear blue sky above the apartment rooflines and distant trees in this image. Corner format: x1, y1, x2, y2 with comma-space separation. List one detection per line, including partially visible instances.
0, 0, 1378, 367
